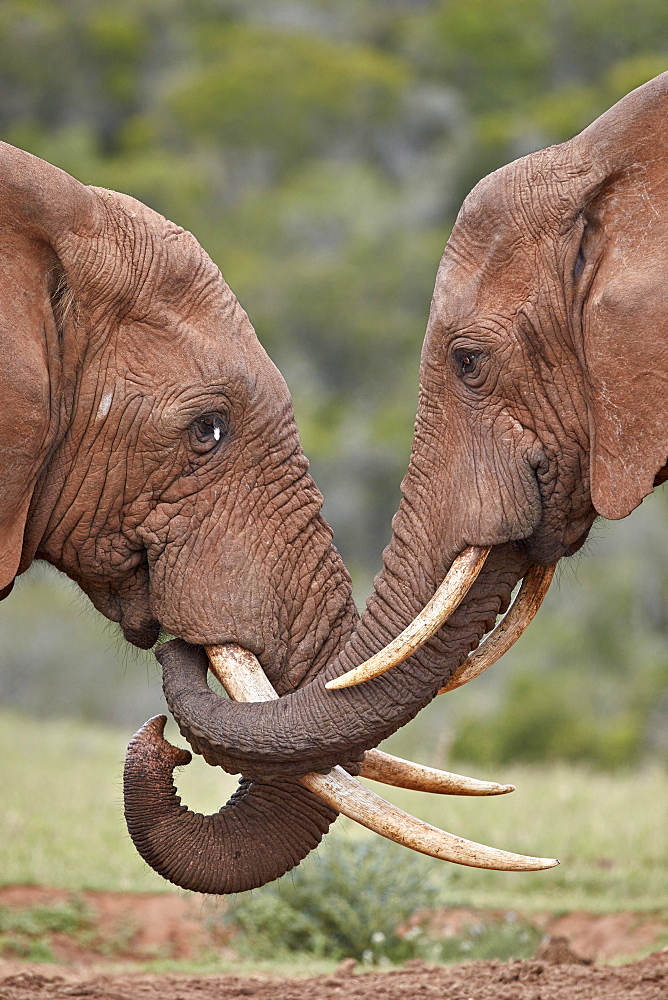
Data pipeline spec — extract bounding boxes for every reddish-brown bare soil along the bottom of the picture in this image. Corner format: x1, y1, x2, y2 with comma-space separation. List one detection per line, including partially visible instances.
0, 886, 668, 1000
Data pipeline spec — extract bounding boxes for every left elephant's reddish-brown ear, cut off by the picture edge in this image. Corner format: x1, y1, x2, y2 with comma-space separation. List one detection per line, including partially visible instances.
0, 143, 101, 597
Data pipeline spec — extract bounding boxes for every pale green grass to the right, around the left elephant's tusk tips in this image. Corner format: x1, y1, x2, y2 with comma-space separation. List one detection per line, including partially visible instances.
350, 764, 668, 913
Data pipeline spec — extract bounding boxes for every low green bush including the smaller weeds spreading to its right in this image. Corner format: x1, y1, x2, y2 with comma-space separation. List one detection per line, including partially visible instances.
224, 837, 541, 965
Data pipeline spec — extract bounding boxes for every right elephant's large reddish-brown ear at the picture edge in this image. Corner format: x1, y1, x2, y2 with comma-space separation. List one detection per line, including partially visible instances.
566, 73, 668, 519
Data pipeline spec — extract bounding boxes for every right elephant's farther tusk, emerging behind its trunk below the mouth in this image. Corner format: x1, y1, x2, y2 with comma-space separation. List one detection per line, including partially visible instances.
436, 565, 556, 694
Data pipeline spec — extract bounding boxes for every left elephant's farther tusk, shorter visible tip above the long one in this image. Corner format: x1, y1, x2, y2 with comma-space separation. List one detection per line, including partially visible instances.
359, 750, 515, 795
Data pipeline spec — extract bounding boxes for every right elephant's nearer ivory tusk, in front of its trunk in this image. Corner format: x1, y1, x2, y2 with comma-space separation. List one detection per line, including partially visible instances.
325, 545, 491, 690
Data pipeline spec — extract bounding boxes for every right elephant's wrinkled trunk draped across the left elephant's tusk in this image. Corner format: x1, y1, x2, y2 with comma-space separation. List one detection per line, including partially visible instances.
157, 488, 529, 780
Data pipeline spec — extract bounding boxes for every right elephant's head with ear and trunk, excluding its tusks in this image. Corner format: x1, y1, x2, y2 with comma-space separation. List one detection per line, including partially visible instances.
159, 75, 668, 775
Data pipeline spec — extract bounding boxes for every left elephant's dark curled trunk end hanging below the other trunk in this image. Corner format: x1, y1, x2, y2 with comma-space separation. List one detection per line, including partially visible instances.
124, 716, 337, 894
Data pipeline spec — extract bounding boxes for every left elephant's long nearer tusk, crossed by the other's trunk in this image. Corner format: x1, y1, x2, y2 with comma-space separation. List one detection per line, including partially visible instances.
205, 643, 559, 871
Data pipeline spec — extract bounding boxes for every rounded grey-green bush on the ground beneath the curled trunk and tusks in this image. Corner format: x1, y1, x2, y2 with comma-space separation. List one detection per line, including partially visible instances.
226, 838, 436, 964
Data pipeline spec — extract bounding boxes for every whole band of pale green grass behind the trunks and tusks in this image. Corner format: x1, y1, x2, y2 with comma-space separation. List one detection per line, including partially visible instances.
0, 712, 668, 912
